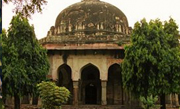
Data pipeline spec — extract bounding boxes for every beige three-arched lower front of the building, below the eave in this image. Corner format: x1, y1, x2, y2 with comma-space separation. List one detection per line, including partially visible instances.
42, 46, 143, 109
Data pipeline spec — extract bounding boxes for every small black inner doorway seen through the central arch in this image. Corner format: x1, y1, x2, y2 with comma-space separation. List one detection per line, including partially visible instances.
85, 84, 97, 104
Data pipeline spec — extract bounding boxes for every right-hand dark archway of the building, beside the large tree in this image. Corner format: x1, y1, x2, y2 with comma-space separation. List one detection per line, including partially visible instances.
107, 64, 124, 105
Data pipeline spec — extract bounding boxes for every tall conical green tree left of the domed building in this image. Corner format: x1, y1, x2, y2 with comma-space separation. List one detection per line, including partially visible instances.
2, 15, 49, 109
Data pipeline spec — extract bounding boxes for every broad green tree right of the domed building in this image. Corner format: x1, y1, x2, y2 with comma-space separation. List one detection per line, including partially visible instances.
122, 18, 180, 109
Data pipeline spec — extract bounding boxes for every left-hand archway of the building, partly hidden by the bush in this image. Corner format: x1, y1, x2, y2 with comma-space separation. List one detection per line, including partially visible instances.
57, 64, 73, 104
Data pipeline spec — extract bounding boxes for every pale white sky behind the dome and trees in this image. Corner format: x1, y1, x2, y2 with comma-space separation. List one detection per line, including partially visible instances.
2, 0, 180, 39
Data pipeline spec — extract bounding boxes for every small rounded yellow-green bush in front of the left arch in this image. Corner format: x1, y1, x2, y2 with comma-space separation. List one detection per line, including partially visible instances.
37, 81, 70, 109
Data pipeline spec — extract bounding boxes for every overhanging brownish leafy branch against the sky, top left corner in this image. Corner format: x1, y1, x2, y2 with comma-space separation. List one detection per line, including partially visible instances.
3, 0, 47, 17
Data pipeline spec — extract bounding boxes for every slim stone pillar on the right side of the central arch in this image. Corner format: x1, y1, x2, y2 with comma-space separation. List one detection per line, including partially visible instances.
101, 81, 107, 105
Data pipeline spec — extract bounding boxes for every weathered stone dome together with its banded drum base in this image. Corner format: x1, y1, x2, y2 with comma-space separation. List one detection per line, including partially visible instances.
44, 0, 130, 43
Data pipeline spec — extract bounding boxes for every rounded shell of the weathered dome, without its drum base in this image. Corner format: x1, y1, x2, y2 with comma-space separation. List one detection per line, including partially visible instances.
55, 0, 128, 34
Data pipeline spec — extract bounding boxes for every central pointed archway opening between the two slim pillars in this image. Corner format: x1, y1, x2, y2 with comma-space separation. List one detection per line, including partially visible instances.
80, 64, 101, 104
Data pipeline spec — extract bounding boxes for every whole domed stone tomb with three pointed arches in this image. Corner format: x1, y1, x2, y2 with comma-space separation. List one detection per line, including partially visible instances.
40, 0, 178, 109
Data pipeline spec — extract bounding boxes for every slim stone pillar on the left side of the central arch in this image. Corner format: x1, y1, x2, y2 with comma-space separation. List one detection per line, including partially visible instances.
73, 81, 78, 105
